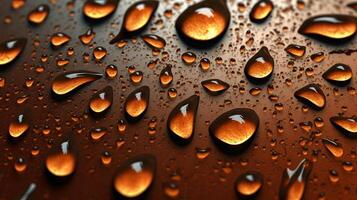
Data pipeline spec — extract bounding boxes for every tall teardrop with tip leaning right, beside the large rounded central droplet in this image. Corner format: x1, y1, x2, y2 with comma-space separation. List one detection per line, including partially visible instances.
167, 95, 200, 144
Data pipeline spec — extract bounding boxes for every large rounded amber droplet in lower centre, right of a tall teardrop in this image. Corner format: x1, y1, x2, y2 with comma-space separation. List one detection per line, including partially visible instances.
209, 108, 259, 153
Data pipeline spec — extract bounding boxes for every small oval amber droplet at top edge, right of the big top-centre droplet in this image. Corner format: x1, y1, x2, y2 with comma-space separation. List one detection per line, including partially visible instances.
249, 0, 274, 23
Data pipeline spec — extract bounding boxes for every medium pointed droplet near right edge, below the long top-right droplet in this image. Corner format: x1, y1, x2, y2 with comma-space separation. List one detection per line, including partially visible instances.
322, 63, 352, 86
